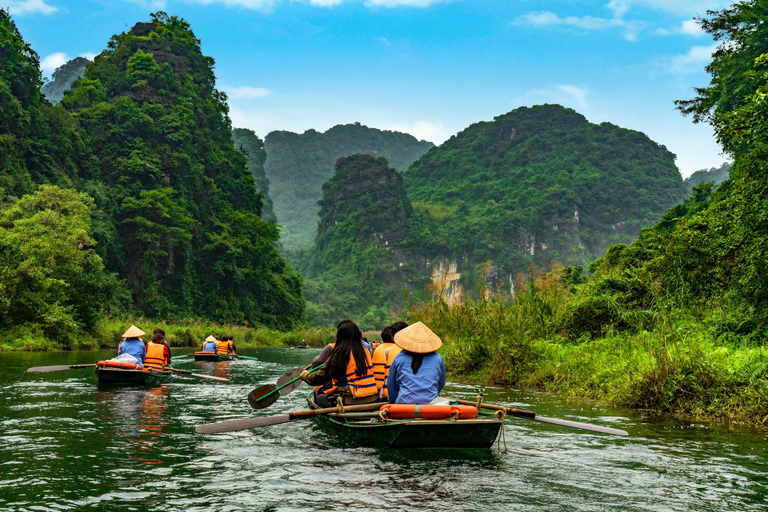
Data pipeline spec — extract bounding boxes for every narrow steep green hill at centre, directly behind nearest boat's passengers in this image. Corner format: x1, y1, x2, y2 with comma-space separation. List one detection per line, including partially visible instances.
298, 155, 428, 330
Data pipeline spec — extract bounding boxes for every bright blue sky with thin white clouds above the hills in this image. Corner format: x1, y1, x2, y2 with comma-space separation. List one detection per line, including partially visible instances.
7, 0, 730, 176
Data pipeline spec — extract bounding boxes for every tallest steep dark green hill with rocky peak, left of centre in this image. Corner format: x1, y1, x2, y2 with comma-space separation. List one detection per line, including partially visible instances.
61, 13, 303, 327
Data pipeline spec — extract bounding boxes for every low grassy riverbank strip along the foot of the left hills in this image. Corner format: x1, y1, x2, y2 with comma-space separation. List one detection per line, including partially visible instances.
0, 318, 335, 351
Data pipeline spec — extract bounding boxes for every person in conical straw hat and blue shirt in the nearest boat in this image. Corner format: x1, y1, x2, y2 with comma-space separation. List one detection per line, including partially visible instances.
387, 322, 445, 405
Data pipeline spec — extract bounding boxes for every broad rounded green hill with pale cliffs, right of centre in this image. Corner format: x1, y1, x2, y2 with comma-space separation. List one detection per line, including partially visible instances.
404, 105, 685, 294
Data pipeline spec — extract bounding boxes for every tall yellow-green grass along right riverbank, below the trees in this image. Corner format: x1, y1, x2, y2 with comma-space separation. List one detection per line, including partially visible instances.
411, 293, 768, 427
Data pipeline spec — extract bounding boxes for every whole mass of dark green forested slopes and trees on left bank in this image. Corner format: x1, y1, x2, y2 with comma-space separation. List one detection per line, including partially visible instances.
0, 10, 304, 348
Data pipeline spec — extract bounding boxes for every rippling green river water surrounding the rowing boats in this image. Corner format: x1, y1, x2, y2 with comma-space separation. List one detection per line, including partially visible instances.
0, 349, 768, 512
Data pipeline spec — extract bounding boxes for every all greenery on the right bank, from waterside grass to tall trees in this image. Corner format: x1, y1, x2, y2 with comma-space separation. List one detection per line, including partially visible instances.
412, 0, 768, 424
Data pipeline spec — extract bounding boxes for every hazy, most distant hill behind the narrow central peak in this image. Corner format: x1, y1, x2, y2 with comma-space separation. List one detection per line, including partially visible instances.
264, 123, 434, 249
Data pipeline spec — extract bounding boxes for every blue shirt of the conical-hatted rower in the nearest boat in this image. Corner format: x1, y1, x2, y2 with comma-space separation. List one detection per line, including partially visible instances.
387, 351, 445, 405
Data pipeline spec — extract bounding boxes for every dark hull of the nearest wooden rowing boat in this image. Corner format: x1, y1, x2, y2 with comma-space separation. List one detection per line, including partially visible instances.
307, 393, 503, 448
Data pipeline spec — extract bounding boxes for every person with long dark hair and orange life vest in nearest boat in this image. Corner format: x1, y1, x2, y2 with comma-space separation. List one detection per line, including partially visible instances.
301, 320, 379, 407
